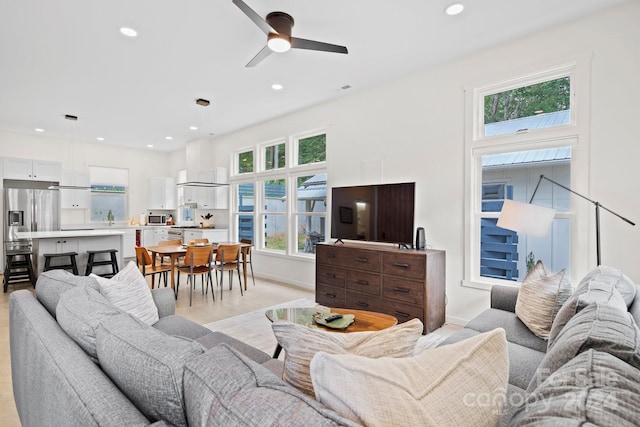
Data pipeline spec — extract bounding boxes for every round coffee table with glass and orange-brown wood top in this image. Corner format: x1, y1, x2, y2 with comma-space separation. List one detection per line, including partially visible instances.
264, 306, 398, 359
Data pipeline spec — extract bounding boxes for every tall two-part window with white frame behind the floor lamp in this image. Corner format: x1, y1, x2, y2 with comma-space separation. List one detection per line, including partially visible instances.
463, 62, 588, 289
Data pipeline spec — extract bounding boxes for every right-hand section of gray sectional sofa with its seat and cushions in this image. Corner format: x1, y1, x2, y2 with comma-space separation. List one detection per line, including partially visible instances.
441, 267, 640, 427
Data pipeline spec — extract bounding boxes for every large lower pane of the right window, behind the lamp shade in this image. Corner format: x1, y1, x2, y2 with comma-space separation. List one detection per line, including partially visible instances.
480, 147, 571, 281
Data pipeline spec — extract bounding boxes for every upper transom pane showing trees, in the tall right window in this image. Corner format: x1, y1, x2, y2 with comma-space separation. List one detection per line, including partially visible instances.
484, 77, 571, 136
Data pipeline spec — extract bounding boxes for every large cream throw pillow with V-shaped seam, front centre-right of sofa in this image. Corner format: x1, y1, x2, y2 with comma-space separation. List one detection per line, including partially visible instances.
311, 329, 509, 427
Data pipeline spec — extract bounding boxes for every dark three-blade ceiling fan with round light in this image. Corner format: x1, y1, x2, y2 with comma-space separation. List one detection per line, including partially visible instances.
232, 0, 349, 67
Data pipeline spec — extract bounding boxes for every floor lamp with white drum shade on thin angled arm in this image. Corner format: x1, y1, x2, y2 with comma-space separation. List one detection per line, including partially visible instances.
496, 175, 636, 265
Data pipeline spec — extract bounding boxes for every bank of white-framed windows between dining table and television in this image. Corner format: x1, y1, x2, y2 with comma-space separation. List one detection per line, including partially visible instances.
231, 132, 327, 257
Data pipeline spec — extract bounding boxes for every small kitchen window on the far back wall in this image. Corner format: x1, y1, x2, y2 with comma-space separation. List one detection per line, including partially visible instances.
89, 166, 129, 222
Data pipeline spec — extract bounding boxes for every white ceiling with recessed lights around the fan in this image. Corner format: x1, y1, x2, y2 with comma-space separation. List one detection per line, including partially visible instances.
0, 0, 625, 151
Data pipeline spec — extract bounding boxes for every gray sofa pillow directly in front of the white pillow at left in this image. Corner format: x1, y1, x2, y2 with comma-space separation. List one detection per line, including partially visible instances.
56, 286, 123, 362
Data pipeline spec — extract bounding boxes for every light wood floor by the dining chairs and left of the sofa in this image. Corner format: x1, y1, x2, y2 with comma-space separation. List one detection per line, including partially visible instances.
0, 275, 315, 427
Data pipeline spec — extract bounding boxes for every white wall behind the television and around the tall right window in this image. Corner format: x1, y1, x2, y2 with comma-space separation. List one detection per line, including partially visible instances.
199, 2, 640, 321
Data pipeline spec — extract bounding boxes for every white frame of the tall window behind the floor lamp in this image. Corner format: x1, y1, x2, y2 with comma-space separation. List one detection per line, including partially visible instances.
461, 56, 592, 290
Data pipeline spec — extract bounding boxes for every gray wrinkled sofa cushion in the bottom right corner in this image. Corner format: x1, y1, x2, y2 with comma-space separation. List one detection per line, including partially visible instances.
509, 349, 640, 427
